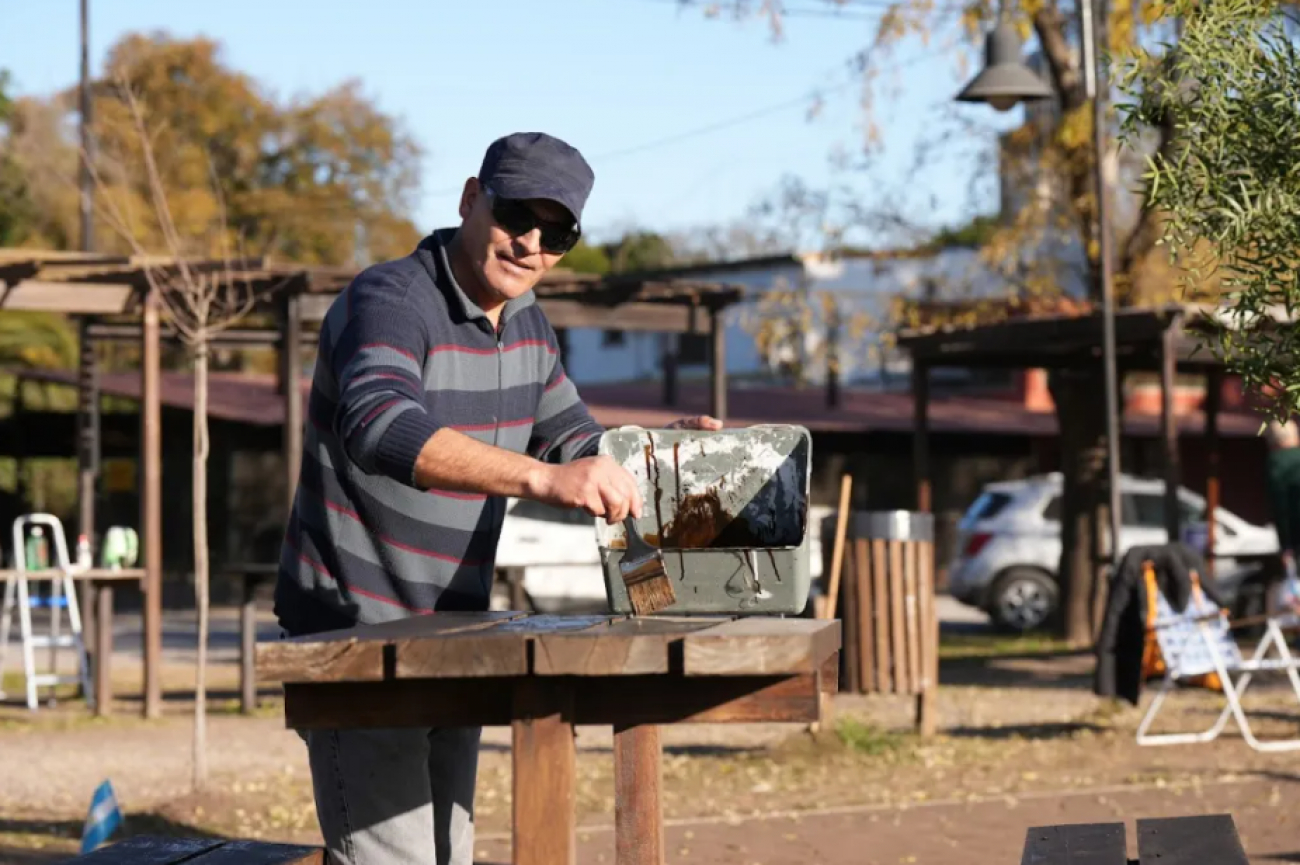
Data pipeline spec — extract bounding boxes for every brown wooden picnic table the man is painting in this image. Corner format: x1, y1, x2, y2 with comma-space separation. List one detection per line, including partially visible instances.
257, 613, 840, 865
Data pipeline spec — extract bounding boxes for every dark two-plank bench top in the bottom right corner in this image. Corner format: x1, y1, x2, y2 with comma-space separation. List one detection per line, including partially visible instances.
1021, 814, 1248, 865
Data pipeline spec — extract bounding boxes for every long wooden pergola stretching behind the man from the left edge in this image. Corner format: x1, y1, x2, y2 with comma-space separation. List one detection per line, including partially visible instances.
0, 248, 744, 717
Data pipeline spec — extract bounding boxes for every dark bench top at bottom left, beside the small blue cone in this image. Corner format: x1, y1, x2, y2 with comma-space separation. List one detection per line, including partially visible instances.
70, 835, 325, 865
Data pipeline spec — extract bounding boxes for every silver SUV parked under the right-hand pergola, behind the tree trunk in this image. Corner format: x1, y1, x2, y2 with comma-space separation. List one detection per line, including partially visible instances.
948, 472, 1278, 631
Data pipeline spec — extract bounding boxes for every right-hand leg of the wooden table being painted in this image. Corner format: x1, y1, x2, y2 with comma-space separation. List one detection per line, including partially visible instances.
614, 725, 663, 865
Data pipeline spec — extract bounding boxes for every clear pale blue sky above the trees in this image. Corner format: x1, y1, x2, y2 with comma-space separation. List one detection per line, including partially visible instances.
0, 0, 1034, 253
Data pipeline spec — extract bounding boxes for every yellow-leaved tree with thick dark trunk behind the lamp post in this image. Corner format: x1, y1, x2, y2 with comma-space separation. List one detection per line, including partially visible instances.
681, 0, 1196, 645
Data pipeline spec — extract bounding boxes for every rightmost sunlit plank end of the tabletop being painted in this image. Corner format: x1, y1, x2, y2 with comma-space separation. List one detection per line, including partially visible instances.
684, 617, 840, 676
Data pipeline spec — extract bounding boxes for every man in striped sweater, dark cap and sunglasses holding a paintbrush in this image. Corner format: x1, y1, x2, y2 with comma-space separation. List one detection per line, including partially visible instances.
276, 133, 722, 865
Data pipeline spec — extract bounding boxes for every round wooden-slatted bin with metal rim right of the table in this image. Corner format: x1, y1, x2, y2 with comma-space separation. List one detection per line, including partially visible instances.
837, 511, 939, 735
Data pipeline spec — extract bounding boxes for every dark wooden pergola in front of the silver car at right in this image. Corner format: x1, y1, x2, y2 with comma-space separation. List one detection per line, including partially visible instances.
897, 304, 1253, 568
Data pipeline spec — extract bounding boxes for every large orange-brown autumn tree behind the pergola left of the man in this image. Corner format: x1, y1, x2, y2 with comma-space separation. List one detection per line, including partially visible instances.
12, 33, 423, 264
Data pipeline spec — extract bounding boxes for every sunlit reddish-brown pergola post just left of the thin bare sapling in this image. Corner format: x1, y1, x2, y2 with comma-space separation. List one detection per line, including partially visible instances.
140, 284, 163, 718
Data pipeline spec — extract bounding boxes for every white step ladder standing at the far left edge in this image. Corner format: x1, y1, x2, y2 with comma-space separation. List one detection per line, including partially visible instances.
0, 514, 95, 712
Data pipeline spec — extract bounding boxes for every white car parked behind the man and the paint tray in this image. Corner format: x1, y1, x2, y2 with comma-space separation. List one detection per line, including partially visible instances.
493, 498, 829, 614
